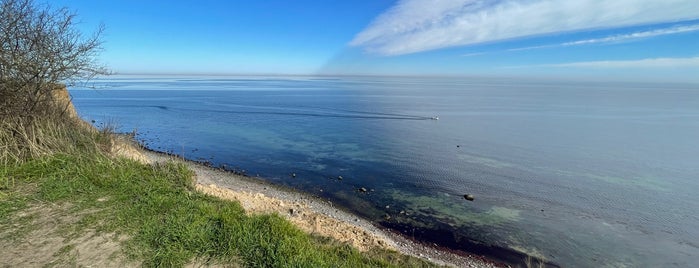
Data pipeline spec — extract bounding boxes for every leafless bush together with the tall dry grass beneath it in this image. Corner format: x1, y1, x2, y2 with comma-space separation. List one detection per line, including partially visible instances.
0, 0, 106, 164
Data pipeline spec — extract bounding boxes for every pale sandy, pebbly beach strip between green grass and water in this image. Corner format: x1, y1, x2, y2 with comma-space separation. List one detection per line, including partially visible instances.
144, 151, 503, 267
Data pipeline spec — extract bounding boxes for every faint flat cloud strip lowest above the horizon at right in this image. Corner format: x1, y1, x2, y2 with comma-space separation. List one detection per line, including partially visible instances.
544, 57, 699, 69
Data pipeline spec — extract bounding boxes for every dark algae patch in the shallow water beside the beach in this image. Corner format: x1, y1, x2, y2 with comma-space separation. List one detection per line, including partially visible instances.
330, 190, 560, 267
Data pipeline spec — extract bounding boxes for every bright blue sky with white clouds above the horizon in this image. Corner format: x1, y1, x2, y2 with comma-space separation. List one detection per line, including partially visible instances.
46, 0, 699, 82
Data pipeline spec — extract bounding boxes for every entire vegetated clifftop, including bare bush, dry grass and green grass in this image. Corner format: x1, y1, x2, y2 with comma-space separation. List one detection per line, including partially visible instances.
0, 0, 432, 267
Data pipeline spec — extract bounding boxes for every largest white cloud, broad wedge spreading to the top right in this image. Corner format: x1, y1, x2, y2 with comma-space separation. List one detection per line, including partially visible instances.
350, 0, 699, 55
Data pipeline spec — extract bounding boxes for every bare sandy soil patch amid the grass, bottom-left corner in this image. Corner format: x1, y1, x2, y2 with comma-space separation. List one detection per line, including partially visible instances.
0, 203, 138, 267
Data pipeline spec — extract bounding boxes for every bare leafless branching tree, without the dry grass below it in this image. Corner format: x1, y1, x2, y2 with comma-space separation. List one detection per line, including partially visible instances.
0, 0, 106, 118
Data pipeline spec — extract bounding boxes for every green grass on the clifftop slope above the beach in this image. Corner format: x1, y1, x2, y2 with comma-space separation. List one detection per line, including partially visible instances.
0, 144, 438, 267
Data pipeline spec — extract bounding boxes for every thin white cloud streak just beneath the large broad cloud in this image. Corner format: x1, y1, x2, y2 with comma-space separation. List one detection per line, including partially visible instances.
507, 24, 699, 51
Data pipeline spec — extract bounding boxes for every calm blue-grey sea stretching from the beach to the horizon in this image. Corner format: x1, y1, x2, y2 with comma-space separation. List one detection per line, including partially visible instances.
71, 77, 699, 267
